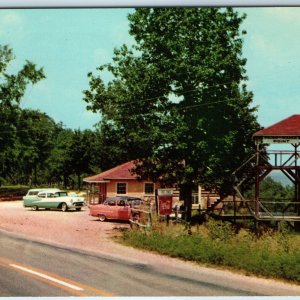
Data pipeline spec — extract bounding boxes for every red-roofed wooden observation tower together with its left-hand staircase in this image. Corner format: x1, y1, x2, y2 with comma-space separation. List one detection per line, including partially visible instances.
233, 115, 300, 230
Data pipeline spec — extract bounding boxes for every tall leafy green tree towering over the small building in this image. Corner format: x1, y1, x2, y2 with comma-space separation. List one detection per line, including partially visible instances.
84, 8, 258, 217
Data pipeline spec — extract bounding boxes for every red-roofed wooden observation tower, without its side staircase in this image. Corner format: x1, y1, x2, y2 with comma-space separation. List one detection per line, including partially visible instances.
253, 115, 300, 227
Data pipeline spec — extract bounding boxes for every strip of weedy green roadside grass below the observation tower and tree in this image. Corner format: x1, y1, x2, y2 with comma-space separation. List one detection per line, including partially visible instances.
122, 220, 300, 283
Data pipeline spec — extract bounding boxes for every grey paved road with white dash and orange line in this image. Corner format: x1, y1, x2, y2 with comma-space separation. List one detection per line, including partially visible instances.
0, 232, 296, 296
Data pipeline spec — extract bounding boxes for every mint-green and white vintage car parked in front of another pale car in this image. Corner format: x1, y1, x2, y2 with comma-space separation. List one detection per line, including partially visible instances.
24, 189, 85, 211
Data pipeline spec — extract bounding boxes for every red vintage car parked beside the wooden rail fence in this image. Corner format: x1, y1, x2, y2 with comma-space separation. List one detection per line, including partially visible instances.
89, 196, 143, 222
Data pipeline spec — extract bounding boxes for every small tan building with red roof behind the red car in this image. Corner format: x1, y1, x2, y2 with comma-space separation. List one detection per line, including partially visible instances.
83, 161, 160, 203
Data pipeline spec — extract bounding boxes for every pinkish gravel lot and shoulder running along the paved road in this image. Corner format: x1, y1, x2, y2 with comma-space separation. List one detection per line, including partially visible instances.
0, 201, 300, 296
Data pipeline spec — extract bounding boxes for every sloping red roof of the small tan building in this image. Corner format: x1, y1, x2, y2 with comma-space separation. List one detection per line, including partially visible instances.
83, 161, 137, 182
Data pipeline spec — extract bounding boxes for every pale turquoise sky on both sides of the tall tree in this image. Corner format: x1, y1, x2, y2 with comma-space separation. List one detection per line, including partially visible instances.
0, 7, 300, 129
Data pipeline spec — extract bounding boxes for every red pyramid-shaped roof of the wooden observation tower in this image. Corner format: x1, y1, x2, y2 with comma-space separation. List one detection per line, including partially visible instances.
253, 115, 300, 138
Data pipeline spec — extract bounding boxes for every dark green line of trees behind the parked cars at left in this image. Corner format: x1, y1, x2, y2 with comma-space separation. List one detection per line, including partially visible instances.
0, 45, 125, 189
